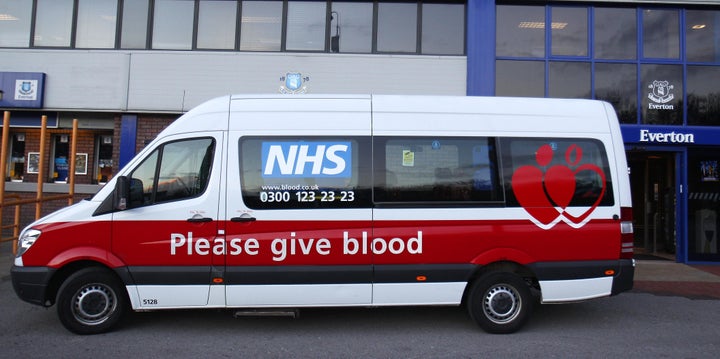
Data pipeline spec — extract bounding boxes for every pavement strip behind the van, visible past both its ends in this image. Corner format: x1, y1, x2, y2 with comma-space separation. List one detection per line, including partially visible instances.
0, 242, 720, 300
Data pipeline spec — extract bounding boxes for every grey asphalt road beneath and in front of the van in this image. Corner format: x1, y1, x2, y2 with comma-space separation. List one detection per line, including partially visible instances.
0, 277, 720, 358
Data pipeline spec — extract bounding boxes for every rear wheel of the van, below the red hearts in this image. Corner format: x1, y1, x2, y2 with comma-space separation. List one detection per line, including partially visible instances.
467, 272, 533, 334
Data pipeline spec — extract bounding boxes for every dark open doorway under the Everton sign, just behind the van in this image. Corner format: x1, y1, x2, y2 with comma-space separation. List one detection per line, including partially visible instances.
628, 151, 678, 260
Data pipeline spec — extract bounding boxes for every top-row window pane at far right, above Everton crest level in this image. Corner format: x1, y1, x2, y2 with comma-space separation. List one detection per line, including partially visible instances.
685, 10, 720, 62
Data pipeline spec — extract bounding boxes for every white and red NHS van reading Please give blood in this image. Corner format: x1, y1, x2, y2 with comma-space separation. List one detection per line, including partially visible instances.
12, 95, 634, 334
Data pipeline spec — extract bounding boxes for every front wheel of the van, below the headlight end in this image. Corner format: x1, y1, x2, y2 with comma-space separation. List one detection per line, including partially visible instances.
56, 268, 128, 334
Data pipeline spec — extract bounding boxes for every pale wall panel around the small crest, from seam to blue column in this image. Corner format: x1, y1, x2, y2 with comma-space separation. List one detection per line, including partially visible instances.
128, 52, 466, 111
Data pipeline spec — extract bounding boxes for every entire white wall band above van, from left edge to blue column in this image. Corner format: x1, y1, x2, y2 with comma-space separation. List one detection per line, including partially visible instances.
0, 49, 467, 112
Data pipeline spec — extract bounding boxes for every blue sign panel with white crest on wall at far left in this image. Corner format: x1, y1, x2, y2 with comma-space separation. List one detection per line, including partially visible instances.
0, 72, 45, 108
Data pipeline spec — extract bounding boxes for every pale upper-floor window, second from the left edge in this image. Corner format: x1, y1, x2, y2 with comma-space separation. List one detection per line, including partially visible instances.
33, 0, 73, 47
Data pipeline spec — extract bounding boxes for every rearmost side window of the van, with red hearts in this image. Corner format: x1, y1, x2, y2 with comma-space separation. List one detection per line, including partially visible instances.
500, 138, 614, 208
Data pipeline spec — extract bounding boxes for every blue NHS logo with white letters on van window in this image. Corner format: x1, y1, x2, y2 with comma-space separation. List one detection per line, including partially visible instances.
262, 142, 352, 178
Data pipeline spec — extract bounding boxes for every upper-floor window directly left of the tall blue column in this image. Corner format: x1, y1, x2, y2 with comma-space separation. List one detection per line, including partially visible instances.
421, 1, 465, 55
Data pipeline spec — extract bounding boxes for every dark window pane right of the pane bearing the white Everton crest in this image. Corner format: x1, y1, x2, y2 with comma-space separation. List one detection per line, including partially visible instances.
687, 66, 720, 126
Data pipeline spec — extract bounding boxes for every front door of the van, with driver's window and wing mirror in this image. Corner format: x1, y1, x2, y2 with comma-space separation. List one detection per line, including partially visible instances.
112, 132, 224, 309
